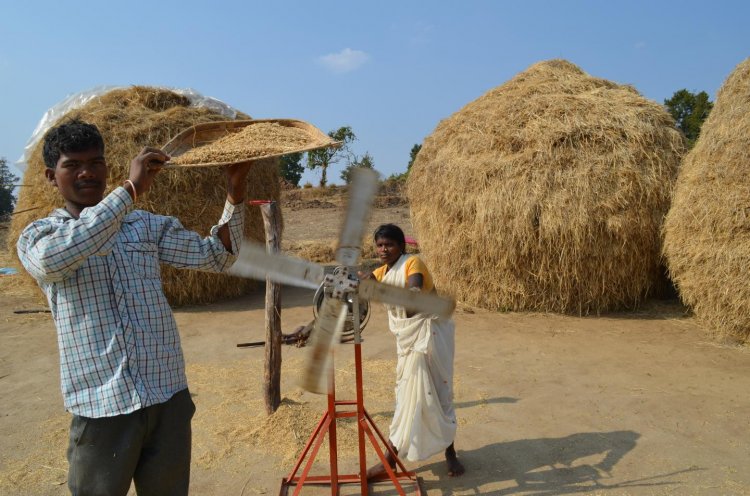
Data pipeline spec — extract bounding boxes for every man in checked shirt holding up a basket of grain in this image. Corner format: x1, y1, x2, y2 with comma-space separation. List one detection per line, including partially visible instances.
17, 120, 249, 496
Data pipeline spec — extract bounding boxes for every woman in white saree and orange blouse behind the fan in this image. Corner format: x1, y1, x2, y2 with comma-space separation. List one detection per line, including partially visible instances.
360, 224, 464, 479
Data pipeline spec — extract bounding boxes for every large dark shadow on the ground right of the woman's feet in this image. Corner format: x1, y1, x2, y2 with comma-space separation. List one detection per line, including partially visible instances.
417, 431, 699, 496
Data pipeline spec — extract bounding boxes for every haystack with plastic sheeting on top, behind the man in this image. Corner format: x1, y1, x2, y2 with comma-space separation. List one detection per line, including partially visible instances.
8, 86, 280, 305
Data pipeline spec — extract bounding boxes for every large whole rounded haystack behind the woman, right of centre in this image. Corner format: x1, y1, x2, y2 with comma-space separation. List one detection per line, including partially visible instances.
407, 60, 685, 314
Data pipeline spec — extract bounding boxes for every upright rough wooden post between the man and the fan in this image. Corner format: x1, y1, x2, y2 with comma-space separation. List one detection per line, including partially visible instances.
260, 201, 281, 415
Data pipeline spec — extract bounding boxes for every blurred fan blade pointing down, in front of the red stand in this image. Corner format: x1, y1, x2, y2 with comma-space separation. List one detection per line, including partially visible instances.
300, 298, 348, 394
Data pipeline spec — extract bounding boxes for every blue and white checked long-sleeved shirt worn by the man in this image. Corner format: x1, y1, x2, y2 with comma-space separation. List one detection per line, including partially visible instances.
17, 188, 244, 418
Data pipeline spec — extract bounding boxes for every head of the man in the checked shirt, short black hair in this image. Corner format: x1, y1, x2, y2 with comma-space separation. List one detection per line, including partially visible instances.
43, 119, 107, 215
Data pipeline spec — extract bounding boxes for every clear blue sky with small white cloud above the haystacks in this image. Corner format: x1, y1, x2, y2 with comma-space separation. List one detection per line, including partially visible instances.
0, 0, 750, 184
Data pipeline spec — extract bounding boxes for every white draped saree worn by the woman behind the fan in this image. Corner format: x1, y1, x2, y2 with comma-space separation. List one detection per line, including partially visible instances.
382, 255, 456, 461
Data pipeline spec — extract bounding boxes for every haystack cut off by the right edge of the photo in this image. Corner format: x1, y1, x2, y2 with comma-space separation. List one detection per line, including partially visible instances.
664, 59, 750, 342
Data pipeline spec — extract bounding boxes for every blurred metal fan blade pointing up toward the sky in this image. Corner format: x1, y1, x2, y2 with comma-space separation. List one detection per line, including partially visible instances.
336, 168, 378, 267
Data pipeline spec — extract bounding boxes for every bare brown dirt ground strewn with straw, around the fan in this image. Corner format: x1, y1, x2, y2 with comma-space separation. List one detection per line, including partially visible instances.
0, 199, 750, 496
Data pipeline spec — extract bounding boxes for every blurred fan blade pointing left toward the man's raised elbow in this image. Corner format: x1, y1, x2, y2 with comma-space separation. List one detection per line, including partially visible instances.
228, 240, 325, 289
